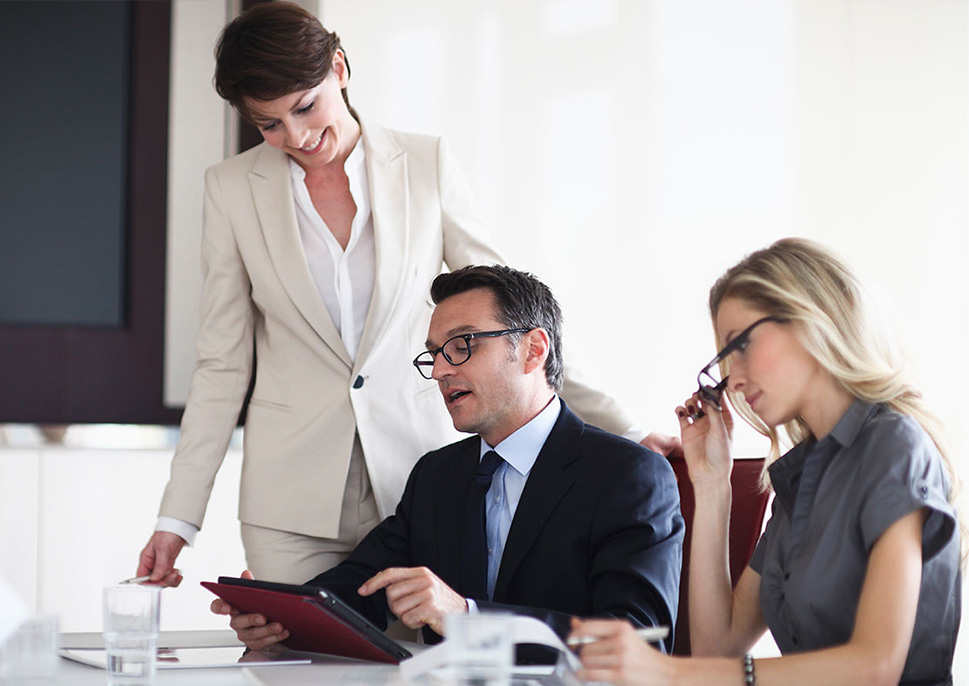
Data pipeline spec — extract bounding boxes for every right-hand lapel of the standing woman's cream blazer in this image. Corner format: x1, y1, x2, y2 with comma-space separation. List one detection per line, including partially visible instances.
357, 124, 410, 367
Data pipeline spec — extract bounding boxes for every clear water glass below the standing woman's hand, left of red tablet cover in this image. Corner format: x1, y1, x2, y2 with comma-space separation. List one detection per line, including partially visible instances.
104, 585, 161, 686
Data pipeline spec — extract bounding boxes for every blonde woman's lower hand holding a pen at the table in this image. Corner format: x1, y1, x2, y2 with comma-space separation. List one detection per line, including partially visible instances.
569, 618, 673, 686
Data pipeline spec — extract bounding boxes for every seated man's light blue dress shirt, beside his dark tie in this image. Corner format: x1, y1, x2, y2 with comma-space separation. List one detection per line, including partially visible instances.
479, 396, 562, 599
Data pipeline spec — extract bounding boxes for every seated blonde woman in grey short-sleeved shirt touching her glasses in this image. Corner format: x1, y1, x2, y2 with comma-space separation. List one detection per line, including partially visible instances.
574, 239, 962, 686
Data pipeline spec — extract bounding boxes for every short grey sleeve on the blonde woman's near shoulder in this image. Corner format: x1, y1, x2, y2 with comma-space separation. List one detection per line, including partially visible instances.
858, 417, 956, 561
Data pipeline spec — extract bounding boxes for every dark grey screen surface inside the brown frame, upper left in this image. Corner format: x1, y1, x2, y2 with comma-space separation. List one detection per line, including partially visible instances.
0, 1, 130, 326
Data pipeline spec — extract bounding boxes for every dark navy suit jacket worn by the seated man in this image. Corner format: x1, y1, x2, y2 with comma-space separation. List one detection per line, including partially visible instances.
309, 403, 684, 650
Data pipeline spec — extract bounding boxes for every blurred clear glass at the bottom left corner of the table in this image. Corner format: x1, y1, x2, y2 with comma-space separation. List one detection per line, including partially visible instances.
0, 615, 60, 686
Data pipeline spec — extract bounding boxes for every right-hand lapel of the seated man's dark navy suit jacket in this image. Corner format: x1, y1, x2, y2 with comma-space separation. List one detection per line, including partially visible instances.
494, 403, 582, 601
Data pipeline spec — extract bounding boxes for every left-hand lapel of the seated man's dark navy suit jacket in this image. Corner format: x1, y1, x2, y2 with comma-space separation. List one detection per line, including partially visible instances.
437, 441, 481, 593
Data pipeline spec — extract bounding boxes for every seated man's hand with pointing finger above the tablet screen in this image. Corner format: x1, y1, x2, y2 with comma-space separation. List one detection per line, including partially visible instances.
357, 567, 468, 636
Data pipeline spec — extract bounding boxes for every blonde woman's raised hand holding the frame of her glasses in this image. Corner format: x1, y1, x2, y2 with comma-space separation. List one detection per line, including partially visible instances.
676, 393, 733, 487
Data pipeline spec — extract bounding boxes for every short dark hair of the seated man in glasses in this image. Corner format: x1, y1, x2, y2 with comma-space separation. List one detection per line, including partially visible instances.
431, 264, 563, 391
